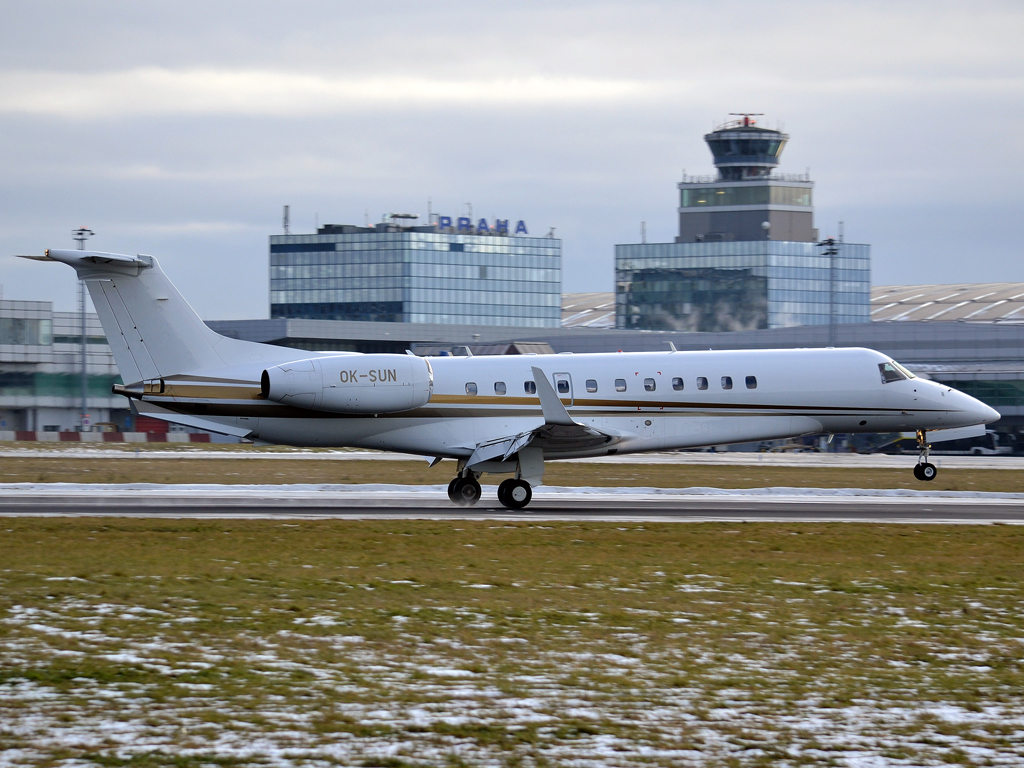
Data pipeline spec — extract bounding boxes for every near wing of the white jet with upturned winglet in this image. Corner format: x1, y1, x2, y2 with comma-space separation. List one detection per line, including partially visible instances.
466, 366, 622, 467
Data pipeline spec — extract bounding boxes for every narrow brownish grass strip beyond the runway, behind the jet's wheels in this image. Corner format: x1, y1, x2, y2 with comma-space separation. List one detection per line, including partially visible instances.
0, 454, 1024, 493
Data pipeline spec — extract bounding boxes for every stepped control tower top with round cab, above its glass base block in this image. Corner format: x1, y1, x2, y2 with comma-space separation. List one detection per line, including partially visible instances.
676, 114, 818, 243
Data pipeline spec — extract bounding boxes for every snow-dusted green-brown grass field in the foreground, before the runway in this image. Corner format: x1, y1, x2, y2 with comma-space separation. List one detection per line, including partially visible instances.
0, 518, 1024, 767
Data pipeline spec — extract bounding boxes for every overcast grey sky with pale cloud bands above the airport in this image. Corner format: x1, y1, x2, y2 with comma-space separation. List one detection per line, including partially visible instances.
0, 0, 1024, 319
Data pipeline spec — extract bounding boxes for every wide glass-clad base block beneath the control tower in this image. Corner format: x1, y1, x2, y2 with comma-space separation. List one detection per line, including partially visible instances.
615, 241, 870, 332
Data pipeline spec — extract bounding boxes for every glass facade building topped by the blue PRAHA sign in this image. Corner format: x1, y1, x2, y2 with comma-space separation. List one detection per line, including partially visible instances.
270, 226, 561, 328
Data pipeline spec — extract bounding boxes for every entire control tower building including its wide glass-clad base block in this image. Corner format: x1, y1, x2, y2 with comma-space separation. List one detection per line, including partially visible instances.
615, 116, 871, 333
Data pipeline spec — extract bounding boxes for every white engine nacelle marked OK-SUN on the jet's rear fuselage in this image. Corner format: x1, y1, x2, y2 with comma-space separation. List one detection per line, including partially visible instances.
260, 354, 434, 414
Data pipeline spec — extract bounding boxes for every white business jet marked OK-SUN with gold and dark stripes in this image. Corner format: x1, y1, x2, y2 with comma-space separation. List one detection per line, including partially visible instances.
26, 250, 999, 509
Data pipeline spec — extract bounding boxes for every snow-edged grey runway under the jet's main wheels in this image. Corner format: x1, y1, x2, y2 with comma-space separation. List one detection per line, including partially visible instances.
0, 483, 1024, 524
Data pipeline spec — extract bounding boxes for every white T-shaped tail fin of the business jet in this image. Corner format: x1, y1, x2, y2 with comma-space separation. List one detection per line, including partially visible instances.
30, 249, 264, 384
